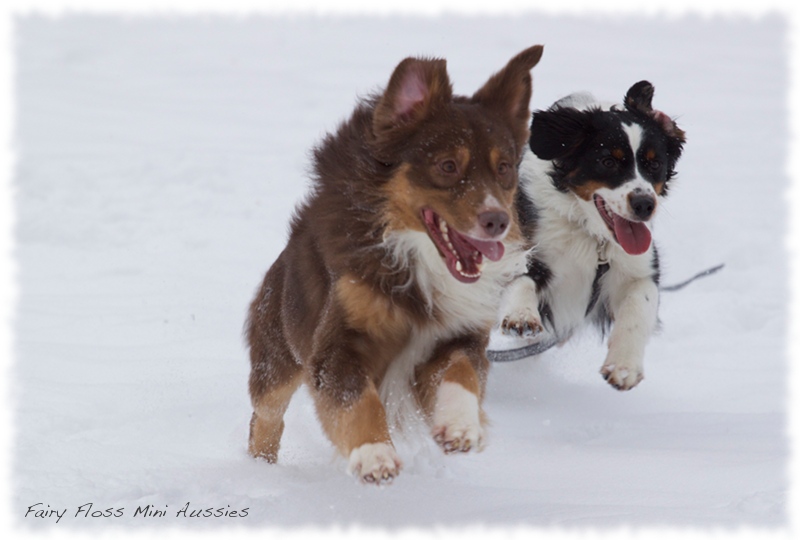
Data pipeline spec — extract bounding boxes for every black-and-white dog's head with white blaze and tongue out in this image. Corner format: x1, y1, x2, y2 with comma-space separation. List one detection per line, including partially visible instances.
530, 81, 685, 255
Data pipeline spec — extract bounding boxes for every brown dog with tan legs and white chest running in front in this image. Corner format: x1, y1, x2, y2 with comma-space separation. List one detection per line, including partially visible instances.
246, 46, 542, 483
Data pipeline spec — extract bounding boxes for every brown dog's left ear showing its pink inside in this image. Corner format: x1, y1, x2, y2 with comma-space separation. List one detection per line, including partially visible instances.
372, 58, 453, 138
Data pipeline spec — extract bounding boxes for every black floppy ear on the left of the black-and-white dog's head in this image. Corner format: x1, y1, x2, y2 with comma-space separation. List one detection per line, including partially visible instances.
529, 107, 593, 160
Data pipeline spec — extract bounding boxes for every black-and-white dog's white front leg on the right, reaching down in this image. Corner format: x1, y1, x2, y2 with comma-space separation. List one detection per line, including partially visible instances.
600, 279, 658, 390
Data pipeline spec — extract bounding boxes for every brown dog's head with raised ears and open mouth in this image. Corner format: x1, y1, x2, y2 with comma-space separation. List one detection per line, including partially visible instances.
370, 45, 542, 283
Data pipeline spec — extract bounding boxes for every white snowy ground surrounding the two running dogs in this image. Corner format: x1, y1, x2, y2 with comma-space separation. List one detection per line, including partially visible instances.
10, 10, 789, 530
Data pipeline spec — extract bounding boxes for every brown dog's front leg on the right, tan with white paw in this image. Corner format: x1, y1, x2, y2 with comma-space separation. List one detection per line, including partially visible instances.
416, 340, 488, 453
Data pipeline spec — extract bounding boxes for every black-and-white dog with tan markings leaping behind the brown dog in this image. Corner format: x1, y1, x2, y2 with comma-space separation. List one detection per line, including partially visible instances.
500, 81, 685, 390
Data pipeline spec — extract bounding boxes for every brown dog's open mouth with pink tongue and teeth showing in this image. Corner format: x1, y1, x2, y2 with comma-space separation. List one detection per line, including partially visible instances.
422, 208, 505, 283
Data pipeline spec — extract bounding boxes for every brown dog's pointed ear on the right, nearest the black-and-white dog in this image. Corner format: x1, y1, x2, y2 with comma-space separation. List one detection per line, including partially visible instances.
472, 45, 544, 148
